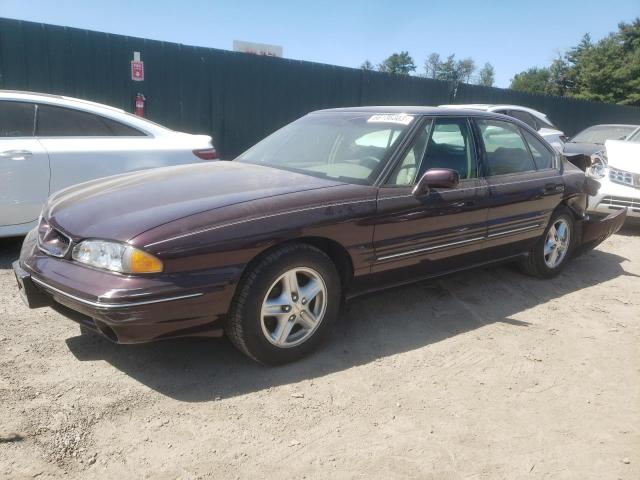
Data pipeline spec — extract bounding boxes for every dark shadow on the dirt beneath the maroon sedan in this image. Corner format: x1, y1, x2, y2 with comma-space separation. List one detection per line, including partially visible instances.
60, 246, 635, 402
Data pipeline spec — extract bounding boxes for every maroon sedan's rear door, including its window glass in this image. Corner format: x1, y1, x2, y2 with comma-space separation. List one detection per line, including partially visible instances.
475, 118, 564, 256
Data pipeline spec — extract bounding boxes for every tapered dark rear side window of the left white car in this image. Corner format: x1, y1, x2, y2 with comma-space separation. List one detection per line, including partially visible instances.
36, 105, 144, 137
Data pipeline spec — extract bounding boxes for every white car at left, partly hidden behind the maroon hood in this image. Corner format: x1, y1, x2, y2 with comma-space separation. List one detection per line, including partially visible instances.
0, 90, 217, 237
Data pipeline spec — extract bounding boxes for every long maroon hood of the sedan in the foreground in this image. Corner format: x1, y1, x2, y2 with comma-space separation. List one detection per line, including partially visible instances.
44, 162, 341, 241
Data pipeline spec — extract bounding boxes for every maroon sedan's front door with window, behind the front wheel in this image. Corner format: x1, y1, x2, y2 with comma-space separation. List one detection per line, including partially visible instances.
372, 117, 487, 280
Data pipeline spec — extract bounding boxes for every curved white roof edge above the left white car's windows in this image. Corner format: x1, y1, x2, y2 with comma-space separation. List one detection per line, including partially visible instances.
0, 90, 173, 135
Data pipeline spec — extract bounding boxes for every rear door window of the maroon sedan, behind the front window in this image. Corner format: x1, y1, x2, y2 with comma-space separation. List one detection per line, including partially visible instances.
477, 119, 536, 176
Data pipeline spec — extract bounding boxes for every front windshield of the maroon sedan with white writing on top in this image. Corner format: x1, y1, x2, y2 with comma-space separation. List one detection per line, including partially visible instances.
236, 113, 414, 185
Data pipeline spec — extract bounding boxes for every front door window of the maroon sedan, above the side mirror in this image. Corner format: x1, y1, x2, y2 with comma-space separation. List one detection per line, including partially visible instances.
387, 118, 476, 186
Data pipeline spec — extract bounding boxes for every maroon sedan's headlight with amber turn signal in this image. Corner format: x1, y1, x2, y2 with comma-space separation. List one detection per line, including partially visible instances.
71, 240, 162, 273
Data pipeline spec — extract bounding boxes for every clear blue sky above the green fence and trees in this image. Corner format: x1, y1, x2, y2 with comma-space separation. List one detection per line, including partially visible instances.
0, 0, 640, 87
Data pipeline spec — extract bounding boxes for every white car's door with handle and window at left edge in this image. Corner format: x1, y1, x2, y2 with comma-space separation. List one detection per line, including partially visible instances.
0, 100, 49, 226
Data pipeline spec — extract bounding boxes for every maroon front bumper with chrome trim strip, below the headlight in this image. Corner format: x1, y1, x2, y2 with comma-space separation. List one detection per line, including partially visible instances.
13, 232, 233, 343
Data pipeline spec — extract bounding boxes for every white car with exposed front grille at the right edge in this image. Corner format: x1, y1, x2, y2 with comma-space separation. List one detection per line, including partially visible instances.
587, 130, 640, 219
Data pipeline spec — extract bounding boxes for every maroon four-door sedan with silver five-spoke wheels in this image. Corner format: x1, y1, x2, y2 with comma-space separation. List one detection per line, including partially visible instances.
14, 107, 625, 364
